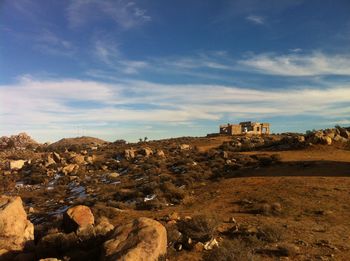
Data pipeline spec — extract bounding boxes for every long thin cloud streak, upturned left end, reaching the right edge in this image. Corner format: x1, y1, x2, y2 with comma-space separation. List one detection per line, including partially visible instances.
89, 49, 350, 79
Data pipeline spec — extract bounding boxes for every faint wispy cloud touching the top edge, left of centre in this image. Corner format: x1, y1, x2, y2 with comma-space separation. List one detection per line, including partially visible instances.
67, 0, 152, 30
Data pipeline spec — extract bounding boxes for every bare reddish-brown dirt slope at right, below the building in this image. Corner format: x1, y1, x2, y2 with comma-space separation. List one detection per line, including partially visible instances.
117, 147, 350, 261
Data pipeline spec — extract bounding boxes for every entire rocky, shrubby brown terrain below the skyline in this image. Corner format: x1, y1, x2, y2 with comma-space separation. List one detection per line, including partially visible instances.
0, 126, 350, 261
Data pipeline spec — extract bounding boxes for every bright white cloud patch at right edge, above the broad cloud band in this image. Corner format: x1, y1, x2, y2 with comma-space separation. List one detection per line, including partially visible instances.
238, 52, 350, 76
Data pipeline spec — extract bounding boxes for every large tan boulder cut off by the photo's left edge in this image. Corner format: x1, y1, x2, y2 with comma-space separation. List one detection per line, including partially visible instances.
0, 196, 34, 251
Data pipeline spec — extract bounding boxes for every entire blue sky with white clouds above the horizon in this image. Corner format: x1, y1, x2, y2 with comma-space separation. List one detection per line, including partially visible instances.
0, 0, 350, 142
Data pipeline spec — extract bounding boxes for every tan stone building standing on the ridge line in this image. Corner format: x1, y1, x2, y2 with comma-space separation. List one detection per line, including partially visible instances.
220, 121, 270, 135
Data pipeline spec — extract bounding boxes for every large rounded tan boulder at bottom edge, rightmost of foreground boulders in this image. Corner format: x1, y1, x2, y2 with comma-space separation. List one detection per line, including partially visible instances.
101, 215, 167, 261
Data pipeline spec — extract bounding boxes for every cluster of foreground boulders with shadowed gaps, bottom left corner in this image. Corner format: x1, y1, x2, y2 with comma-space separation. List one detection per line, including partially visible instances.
0, 196, 167, 261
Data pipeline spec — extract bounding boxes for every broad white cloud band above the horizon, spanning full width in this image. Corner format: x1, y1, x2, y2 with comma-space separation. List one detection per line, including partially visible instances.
0, 76, 350, 139
